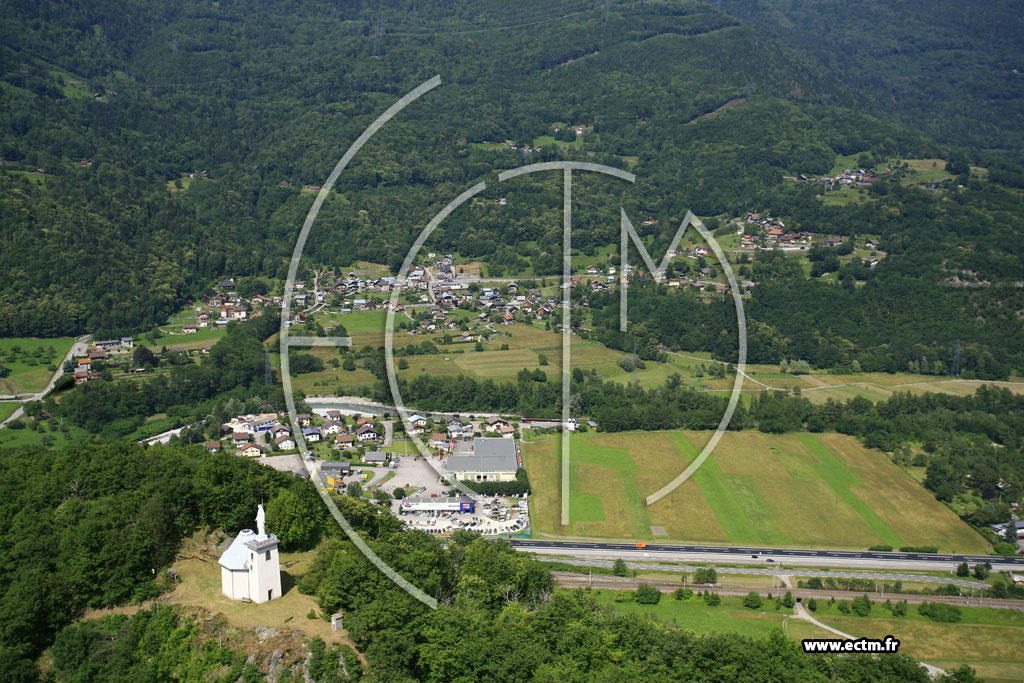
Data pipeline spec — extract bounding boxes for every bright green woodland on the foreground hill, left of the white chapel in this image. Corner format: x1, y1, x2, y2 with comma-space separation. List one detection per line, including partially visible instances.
0, 441, 330, 680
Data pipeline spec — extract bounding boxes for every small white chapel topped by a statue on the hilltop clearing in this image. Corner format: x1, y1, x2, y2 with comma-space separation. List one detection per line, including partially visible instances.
220, 505, 281, 602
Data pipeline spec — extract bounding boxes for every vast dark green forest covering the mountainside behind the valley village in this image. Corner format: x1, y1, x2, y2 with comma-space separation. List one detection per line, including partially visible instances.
0, 0, 1024, 377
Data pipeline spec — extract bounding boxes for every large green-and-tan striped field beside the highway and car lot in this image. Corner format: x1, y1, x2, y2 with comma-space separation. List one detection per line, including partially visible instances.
523, 431, 986, 553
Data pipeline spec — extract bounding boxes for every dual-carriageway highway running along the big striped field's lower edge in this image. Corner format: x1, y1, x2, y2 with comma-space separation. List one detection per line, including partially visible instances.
509, 539, 1024, 572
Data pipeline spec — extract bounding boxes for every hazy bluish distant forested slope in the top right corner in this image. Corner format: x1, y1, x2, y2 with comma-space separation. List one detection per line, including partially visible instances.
719, 0, 1024, 164
